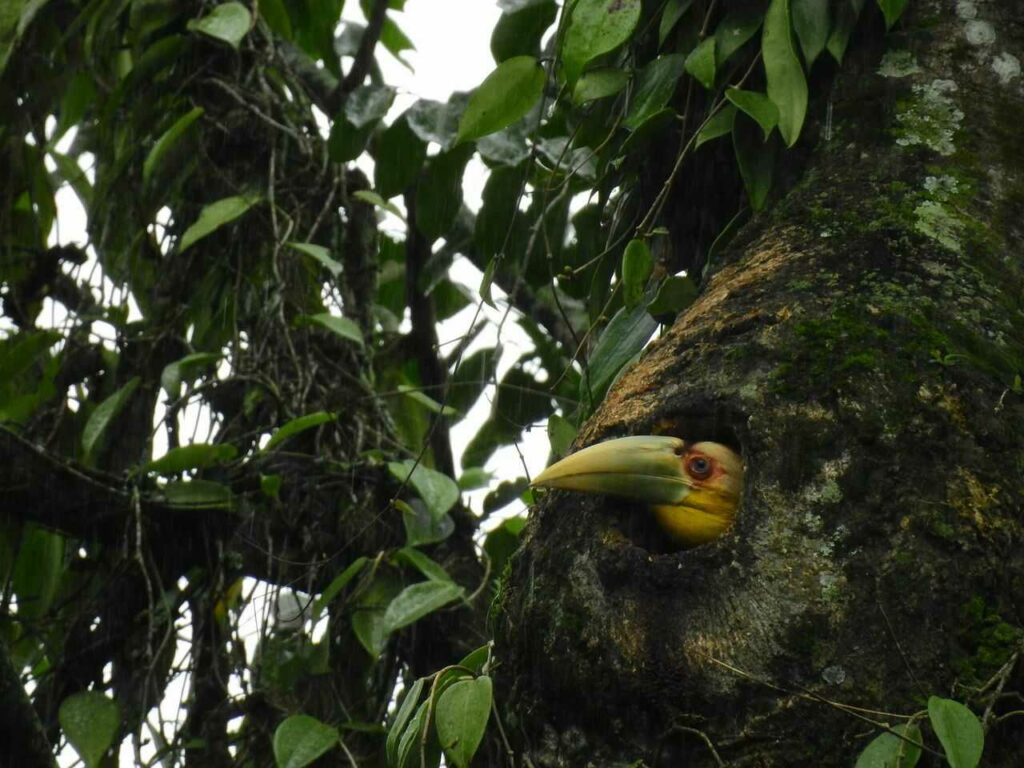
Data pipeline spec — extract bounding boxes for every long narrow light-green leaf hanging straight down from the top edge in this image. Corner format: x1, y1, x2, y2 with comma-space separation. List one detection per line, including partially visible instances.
761, 0, 807, 146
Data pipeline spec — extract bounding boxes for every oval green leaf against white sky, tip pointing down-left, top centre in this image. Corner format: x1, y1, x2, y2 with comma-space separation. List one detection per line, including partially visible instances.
455, 56, 547, 143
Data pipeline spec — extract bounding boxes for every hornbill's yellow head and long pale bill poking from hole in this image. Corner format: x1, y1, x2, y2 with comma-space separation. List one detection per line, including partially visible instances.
531, 435, 743, 547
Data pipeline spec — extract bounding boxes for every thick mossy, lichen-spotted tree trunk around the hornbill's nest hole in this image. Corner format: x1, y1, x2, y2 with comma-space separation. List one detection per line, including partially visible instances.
498, 0, 1024, 768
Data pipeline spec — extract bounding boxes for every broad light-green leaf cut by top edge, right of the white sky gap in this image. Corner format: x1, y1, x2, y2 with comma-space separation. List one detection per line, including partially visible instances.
562, 0, 642, 84
